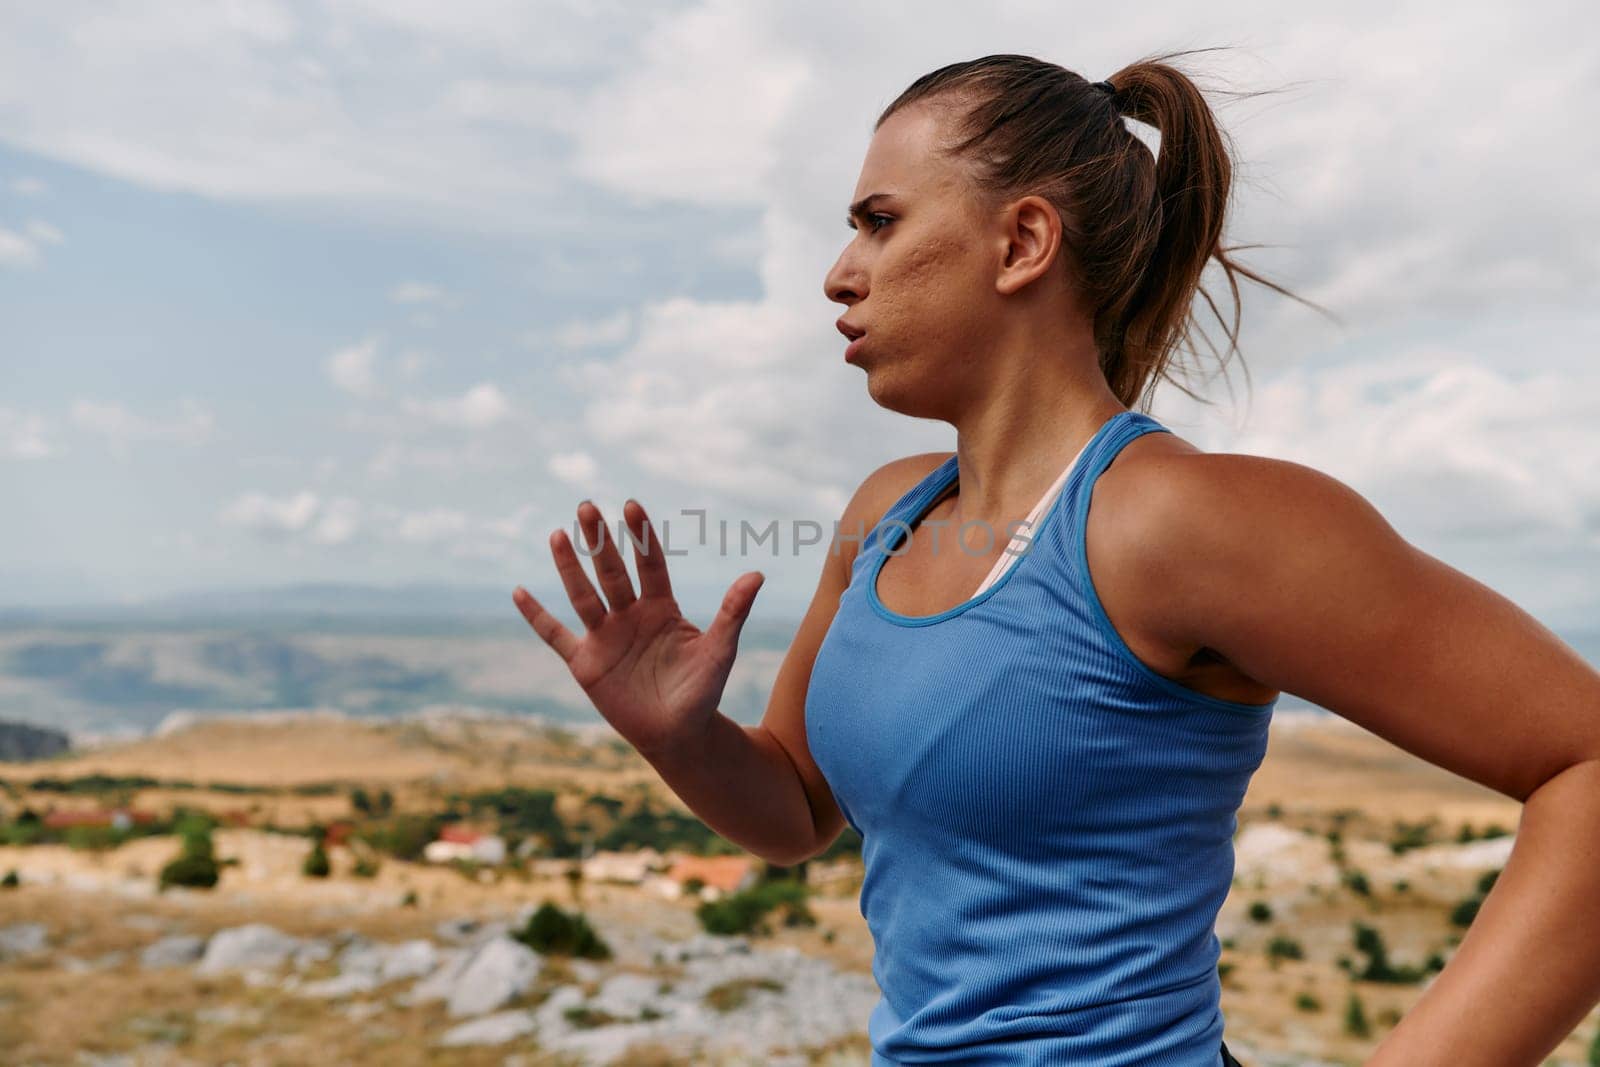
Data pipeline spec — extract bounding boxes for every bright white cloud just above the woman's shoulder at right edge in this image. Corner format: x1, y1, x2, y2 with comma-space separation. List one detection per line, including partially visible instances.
1174, 346, 1600, 550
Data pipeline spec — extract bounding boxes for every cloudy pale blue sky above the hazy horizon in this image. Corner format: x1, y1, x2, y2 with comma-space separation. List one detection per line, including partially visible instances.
0, 0, 1600, 627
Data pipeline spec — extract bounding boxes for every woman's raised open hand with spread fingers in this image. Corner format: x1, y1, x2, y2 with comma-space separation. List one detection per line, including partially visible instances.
512, 499, 765, 758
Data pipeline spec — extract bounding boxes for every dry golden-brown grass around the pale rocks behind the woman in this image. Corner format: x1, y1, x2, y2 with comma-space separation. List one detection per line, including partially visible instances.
0, 715, 1597, 1067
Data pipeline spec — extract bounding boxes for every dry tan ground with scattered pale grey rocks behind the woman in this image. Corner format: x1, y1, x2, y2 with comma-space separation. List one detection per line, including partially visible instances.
0, 715, 1600, 1067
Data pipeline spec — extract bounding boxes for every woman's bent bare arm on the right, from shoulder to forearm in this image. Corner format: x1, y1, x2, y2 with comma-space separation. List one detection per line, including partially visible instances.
1107, 453, 1600, 1067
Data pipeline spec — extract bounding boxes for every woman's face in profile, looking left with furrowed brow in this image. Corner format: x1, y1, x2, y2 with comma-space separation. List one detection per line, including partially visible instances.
822, 104, 1003, 418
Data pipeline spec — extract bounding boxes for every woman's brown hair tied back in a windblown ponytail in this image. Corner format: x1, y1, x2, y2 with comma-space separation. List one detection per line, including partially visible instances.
874, 48, 1325, 411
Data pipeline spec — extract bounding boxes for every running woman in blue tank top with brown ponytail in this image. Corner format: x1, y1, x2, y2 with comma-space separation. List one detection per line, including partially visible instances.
514, 53, 1600, 1067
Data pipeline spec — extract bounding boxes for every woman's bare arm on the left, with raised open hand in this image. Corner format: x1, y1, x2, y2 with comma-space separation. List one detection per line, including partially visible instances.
514, 453, 944, 865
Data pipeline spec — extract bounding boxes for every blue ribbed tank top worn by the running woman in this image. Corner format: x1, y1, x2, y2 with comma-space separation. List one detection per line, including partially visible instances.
805, 404, 1277, 1067
